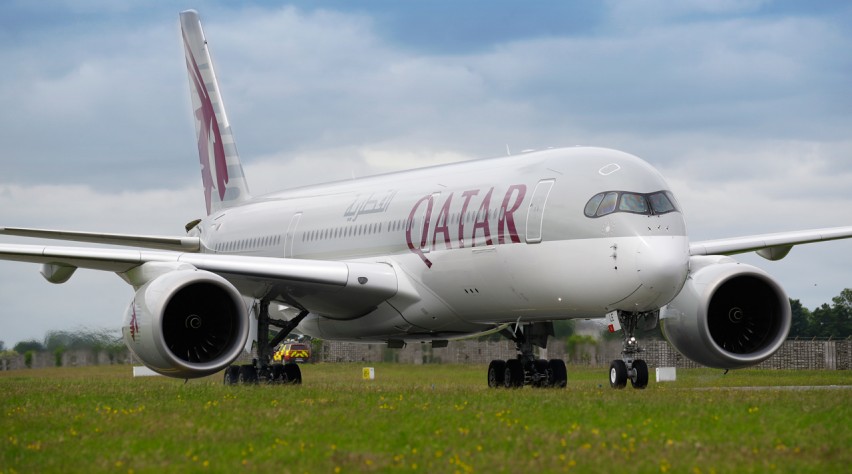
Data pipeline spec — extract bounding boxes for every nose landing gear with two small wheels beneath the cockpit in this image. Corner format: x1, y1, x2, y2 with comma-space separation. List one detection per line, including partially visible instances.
609, 311, 660, 389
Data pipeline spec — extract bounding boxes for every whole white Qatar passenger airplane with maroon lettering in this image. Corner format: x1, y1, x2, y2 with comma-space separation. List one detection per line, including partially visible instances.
0, 10, 852, 389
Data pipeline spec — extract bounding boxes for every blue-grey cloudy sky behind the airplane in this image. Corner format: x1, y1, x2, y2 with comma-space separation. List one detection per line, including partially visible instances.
0, 0, 852, 347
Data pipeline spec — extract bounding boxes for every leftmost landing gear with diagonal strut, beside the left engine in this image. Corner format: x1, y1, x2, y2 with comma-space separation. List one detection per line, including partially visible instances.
225, 299, 308, 385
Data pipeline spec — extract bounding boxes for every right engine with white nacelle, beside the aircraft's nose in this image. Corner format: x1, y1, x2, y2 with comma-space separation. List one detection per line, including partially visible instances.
660, 257, 792, 369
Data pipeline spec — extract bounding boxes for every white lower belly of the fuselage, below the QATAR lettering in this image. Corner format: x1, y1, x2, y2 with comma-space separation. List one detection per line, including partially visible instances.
302, 237, 687, 341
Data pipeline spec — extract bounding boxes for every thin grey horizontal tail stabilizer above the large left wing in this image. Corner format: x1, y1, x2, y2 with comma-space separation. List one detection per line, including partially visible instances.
0, 227, 201, 252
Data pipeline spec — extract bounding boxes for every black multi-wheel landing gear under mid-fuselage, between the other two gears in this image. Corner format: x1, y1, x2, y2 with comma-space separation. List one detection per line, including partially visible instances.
488, 322, 568, 388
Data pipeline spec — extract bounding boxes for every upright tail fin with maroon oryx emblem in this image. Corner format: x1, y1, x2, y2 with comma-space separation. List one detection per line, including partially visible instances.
180, 10, 249, 214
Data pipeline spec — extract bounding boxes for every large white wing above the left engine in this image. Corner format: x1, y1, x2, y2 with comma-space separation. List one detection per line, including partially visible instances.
0, 244, 398, 318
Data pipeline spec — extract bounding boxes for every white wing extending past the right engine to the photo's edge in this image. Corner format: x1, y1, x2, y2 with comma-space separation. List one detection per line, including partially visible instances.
689, 226, 852, 260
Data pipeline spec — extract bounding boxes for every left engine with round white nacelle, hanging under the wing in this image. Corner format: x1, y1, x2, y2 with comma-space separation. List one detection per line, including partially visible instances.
122, 270, 249, 378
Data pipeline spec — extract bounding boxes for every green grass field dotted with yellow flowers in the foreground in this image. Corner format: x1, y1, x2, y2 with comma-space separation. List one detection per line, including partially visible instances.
0, 364, 852, 474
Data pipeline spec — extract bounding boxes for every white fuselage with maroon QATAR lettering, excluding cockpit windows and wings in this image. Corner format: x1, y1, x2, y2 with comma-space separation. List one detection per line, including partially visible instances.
190, 147, 689, 341
